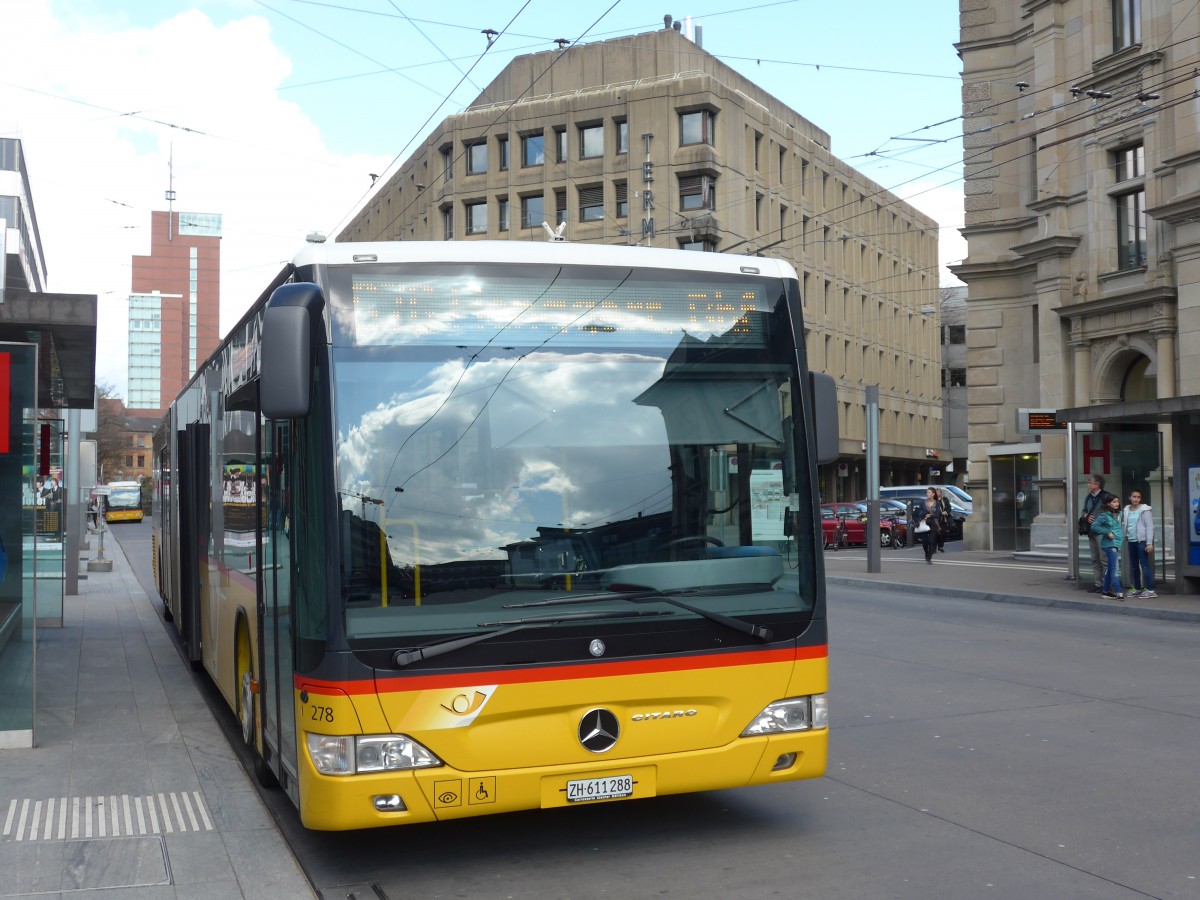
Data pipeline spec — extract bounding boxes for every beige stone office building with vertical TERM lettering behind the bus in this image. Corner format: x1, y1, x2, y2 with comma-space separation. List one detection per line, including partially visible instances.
337, 28, 942, 508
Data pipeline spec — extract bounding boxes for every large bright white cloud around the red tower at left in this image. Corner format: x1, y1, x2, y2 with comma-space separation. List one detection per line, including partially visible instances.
0, 0, 388, 395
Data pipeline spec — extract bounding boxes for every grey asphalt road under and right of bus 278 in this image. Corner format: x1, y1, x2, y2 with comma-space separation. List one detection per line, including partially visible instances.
117, 520, 1200, 900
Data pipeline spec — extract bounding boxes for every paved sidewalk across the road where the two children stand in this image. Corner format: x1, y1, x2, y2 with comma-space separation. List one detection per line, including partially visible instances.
824, 547, 1200, 623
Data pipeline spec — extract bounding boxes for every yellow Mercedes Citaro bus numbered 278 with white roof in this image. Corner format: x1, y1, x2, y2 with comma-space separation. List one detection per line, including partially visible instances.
152, 241, 838, 829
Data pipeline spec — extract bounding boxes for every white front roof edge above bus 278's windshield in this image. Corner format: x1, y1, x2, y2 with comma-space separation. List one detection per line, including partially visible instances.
293, 241, 796, 278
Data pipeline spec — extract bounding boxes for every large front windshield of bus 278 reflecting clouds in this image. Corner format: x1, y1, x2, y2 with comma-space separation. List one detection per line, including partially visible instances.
328, 265, 814, 646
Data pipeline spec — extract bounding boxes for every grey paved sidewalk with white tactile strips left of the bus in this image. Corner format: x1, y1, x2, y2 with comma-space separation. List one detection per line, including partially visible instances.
0, 532, 316, 900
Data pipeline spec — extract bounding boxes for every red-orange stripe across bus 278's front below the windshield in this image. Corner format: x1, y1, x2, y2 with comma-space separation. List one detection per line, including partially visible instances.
295, 644, 829, 695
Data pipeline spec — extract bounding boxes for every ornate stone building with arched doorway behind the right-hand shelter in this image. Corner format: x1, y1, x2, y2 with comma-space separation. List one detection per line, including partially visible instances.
954, 0, 1200, 561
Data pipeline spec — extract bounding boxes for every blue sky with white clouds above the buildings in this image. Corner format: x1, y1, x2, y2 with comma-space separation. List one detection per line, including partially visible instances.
0, 0, 966, 397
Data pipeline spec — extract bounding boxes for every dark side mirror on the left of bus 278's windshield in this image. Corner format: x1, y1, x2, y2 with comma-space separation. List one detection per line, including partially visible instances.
258, 283, 324, 419
